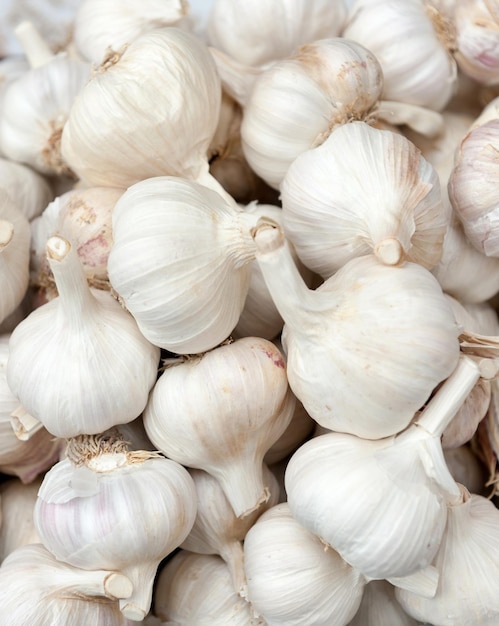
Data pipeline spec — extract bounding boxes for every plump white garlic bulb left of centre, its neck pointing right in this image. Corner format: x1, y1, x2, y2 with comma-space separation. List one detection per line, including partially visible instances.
108, 176, 258, 354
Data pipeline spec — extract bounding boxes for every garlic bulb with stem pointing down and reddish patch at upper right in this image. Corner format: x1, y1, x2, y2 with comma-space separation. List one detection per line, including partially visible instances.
143, 337, 295, 517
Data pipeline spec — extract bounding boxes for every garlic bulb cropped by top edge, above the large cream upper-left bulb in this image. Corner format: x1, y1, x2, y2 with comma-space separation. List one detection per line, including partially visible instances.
73, 0, 189, 63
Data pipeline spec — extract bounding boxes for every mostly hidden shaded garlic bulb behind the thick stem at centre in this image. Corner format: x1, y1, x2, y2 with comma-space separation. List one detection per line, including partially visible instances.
232, 202, 312, 340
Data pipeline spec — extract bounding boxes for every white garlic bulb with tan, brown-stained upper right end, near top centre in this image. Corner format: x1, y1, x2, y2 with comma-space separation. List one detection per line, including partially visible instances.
241, 37, 383, 189
